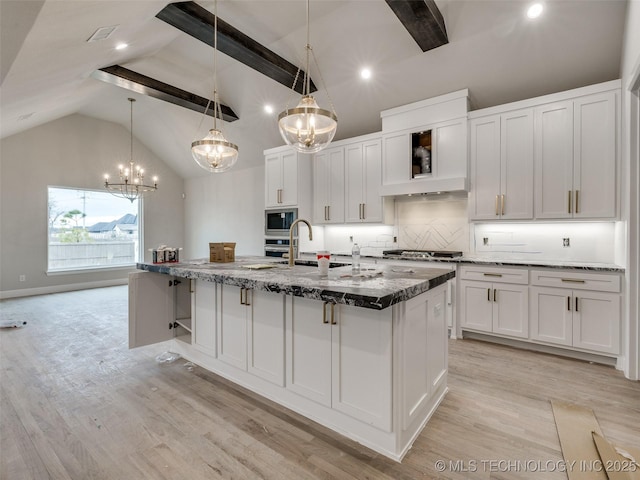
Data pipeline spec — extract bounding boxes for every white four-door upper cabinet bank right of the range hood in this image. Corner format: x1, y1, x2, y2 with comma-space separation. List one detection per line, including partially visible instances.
469, 81, 620, 220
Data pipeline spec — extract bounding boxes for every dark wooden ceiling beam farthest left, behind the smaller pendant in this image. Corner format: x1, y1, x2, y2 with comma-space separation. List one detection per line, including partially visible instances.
91, 65, 238, 122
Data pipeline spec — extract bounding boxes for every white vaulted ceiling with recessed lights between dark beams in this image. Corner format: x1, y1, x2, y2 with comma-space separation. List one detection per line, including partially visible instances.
0, 0, 637, 178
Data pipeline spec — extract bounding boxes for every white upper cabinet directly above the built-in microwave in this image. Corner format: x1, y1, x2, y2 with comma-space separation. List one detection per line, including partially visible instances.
264, 146, 312, 216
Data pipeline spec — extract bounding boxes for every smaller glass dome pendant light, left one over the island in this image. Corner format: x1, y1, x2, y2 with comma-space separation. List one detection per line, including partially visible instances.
191, 0, 238, 173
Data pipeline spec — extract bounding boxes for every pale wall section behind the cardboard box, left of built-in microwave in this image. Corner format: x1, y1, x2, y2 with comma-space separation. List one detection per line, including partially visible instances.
183, 163, 264, 258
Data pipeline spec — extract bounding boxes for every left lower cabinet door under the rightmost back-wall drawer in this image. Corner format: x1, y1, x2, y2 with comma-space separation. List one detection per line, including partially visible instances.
529, 287, 573, 346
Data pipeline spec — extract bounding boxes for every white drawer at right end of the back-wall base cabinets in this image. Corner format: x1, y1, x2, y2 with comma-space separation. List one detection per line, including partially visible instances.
531, 270, 620, 293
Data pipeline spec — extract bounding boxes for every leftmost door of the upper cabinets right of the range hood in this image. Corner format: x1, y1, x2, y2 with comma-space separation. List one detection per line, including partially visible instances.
469, 115, 500, 220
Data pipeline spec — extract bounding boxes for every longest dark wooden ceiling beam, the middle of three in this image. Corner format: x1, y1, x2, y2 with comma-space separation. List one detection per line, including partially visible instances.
156, 2, 317, 94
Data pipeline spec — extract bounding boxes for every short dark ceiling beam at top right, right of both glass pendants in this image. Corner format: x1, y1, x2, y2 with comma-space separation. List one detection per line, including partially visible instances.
386, 0, 449, 52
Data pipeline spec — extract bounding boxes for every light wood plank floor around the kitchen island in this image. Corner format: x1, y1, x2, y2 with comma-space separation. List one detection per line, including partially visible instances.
0, 287, 640, 480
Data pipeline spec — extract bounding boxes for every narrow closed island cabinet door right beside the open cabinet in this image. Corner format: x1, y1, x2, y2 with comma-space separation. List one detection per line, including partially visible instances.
192, 280, 216, 357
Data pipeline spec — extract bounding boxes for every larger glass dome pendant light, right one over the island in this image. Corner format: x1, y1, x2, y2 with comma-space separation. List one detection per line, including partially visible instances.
278, 0, 338, 153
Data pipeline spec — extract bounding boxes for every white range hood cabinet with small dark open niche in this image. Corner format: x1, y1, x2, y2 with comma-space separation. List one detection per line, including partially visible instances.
381, 90, 468, 195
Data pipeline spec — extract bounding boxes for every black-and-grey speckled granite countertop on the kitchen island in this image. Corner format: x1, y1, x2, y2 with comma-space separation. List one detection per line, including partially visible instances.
136, 257, 455, 310
